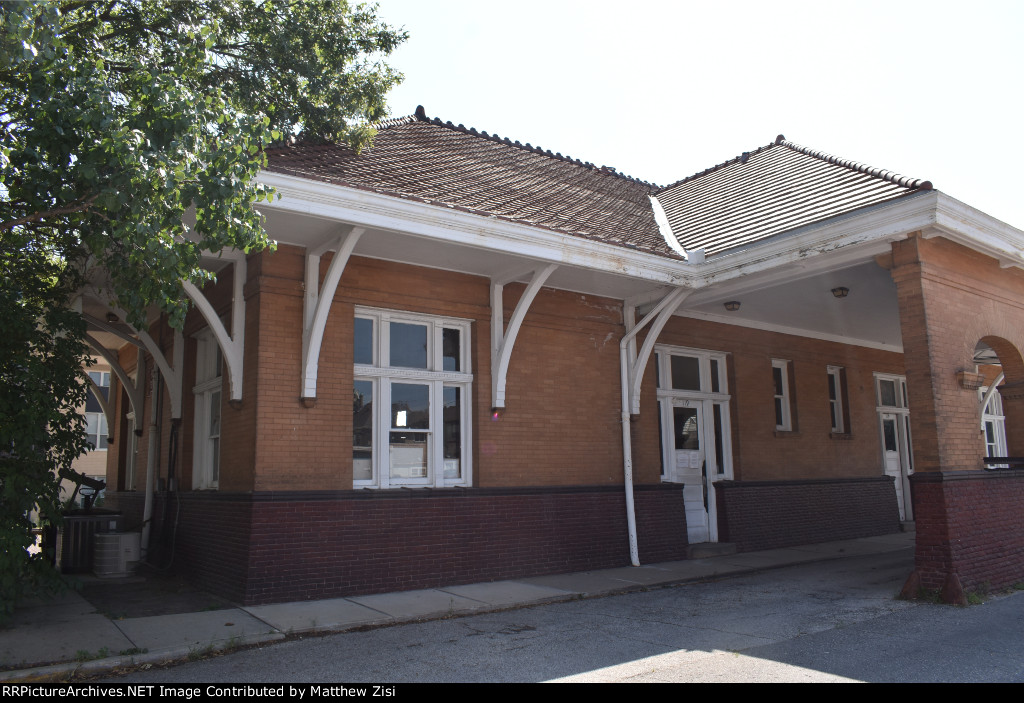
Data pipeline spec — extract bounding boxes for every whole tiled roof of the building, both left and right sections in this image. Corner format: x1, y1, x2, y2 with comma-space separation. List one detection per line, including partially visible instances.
267, 111, 932, 258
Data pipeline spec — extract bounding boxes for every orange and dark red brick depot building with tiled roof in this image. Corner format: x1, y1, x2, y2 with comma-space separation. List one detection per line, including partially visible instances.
84, 107, 1024, 604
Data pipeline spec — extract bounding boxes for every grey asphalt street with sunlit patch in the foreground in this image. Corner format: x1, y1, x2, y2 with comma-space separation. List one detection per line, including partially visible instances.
103, 550, 1024, 684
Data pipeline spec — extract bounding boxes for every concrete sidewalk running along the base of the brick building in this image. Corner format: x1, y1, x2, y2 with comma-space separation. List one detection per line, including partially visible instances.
0, 532, 914, 680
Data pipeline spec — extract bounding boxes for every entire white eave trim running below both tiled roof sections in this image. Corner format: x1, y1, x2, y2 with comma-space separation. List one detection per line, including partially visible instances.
259, 172, 1024, 289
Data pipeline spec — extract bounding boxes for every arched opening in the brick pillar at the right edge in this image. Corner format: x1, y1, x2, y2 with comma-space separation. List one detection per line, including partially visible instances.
974, 337, 1024, 468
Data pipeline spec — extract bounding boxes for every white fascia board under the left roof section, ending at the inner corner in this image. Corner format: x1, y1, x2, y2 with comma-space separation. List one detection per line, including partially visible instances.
258, 172, 695, 287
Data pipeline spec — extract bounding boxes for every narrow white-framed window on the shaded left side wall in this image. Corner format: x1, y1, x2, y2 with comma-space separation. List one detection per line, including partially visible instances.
193, 327, 224, 490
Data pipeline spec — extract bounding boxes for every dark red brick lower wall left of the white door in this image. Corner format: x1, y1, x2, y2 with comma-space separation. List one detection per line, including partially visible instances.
112, 485, 686, 605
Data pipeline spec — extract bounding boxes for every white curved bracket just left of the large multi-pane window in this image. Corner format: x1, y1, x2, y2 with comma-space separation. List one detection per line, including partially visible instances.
300, 227, 366, 404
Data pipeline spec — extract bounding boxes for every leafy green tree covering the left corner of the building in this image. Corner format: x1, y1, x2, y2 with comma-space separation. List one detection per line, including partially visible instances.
0, 0, 406, 618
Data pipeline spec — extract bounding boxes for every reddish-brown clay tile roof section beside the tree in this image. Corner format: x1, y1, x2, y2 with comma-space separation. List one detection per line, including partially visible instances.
267, 106, 680, 258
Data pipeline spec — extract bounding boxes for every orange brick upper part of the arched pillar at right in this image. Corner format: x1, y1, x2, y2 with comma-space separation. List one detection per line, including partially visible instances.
892, 237, 1024, 471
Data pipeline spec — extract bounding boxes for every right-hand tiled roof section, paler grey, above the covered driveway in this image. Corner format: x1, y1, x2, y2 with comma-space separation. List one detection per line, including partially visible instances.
655, 135, 932, 256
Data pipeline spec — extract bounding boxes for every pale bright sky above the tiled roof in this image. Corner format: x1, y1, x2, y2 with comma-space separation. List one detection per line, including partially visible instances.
379, 0, 1024, 229
